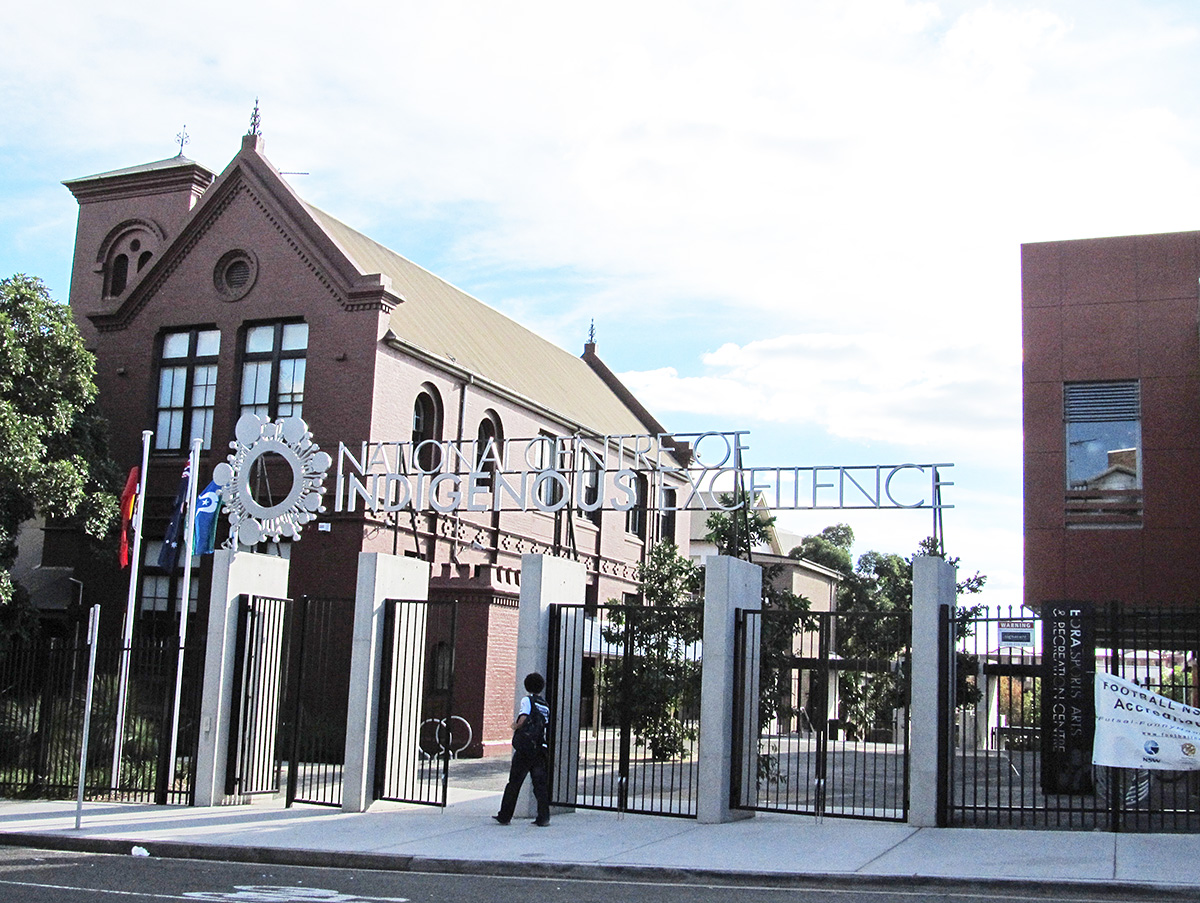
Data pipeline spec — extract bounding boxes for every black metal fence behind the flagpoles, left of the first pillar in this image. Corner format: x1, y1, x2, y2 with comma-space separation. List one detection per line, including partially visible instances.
0, 630, 204, 805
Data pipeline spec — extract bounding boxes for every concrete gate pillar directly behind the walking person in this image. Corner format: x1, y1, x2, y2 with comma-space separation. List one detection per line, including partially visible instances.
512, 555, 588, 818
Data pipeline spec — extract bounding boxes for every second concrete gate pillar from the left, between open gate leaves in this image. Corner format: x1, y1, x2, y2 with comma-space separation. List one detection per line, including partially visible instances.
342, 552, 430, 812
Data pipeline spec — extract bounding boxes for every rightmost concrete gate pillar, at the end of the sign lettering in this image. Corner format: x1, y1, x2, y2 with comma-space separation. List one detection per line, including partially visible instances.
908, 555, 958, 827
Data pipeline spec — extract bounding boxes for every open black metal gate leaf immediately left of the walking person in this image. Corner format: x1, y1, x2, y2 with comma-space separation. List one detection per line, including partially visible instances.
374, 599, 456, 806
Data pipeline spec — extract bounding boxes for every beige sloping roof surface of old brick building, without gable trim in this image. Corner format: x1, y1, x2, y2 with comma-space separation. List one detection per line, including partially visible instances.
306, 203, 661, 435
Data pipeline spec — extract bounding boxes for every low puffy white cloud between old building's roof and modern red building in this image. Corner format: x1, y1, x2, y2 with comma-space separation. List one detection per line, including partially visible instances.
620, 333, 1020, 467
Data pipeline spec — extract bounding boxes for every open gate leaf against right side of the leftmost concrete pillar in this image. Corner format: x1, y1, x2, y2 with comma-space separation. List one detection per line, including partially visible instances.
226, 596, 293, 796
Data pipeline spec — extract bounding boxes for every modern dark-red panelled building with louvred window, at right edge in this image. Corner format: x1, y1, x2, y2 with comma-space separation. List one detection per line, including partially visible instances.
1021, 226, 1200, 606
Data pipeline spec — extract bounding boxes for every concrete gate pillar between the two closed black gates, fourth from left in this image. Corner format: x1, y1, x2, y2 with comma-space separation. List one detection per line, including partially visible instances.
696, 555, 762, 824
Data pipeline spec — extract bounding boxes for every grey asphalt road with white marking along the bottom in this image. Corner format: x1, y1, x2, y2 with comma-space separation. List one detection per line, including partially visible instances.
0, 848, 1183, 903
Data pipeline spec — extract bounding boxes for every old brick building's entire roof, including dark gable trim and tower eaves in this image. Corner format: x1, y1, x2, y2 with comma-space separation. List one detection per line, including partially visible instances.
64, 134, 664, 435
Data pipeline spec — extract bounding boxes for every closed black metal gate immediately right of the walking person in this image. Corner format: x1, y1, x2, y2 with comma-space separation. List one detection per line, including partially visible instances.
546, 605, 703, 818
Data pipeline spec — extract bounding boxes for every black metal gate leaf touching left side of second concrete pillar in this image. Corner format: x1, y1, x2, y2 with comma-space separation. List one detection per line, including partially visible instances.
283, 596, 354, 806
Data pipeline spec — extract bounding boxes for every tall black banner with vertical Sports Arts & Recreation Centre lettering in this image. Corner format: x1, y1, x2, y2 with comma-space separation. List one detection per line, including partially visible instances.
1042, 603, 1096, 794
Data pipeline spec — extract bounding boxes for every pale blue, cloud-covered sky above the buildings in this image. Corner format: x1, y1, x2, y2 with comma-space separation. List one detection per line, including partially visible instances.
0, 0, 1200, 606
